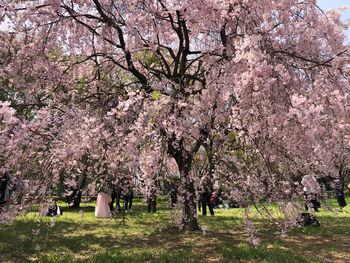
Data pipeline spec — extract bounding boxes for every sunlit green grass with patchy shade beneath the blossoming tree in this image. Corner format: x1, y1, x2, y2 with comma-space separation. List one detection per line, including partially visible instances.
0, 199, 350, 262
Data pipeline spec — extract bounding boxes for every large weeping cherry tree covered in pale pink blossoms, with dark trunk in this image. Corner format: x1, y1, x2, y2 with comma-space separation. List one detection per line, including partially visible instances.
0, 0, 349, 233
